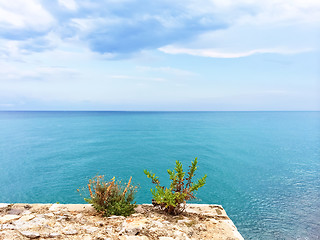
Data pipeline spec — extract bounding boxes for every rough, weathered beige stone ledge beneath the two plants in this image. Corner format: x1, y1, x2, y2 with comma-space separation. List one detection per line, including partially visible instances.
0, 203, 243, 240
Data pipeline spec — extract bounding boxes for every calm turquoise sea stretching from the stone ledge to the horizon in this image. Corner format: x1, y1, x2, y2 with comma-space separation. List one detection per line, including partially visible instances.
0, 112, 320, 239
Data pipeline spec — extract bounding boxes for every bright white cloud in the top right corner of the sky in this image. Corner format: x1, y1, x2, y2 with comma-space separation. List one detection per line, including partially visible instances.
186, 0, 320, 24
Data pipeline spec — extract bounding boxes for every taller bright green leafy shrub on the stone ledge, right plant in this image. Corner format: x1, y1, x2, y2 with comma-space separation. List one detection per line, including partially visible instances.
144, 158, 207, 215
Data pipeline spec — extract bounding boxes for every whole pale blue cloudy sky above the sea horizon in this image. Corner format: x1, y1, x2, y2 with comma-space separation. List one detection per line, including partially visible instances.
0, 0, 320, 111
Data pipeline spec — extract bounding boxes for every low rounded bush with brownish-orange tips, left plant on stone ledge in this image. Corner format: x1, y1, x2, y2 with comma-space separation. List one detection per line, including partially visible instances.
80, 176, 137, 217
